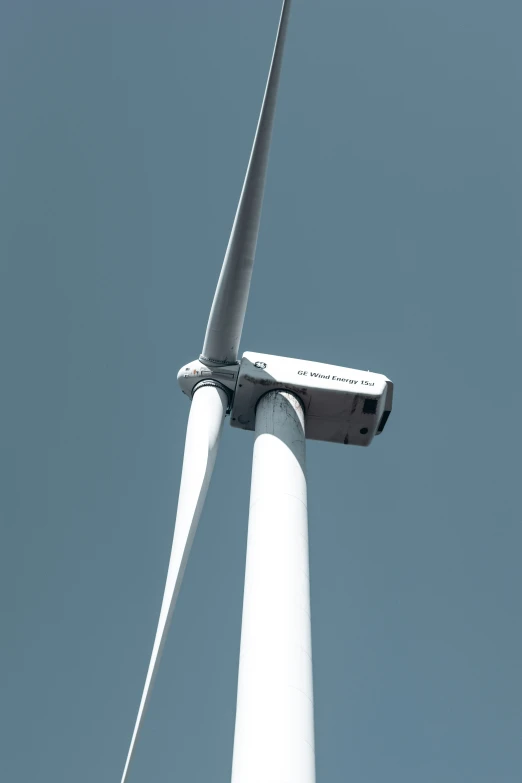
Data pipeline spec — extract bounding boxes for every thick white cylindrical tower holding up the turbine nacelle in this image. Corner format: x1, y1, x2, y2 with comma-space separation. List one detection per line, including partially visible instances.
232, 391, 315, 783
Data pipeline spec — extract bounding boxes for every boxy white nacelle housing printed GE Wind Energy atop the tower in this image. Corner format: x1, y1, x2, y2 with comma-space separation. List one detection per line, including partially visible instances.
231, 351, 393, 446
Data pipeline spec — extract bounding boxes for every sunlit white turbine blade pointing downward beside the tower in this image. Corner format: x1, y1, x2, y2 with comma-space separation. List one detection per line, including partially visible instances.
121, 385, 228, 783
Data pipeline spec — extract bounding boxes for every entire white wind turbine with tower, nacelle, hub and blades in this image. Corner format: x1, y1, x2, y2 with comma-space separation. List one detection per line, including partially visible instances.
121, 0, 393, 783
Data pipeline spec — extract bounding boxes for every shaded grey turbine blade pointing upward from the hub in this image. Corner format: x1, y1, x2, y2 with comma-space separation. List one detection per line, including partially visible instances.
200, 0, 290, 364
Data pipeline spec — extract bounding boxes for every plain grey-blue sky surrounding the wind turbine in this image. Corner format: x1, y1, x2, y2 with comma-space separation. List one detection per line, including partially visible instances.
0, 0, 522, 783
